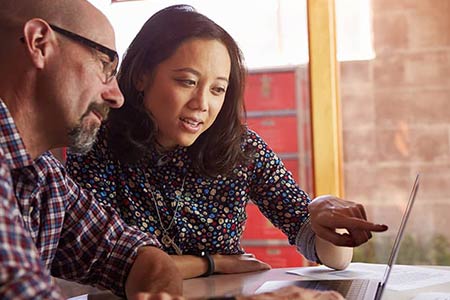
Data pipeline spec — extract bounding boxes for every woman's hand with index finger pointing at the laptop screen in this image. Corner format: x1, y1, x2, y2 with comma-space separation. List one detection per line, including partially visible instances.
308, 195, 388, 247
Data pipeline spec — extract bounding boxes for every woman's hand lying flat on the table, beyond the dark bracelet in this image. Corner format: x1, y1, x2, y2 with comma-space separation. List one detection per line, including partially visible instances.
212, 253, 270, 274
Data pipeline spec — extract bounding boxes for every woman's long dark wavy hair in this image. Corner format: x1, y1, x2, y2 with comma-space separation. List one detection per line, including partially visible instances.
108, 5, 248, 176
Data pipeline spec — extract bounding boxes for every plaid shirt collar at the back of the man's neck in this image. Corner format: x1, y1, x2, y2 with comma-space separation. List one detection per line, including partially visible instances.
0, 99, 33, 169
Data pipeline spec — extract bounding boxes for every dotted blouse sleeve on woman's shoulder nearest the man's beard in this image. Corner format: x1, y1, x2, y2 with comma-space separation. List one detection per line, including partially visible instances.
66, 129, 120, 213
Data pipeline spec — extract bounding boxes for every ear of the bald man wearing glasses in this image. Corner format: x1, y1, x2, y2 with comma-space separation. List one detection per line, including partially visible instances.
23, 19, 55, 69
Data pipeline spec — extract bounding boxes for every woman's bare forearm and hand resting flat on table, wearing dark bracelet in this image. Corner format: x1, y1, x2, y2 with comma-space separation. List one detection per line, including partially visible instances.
171, 254, 270, 279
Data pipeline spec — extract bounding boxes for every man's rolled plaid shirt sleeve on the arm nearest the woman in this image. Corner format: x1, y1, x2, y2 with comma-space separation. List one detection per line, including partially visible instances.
46, 158, 160, 296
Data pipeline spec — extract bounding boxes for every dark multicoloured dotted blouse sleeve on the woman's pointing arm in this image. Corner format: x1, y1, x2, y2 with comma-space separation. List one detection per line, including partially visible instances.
245, 131, 318, 261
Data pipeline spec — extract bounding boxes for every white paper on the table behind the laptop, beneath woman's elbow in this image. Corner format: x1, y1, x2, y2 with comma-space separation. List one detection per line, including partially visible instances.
288, 263, 450, 291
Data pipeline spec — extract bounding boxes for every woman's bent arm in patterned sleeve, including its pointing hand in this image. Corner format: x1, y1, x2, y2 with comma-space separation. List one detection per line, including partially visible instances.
243, 132, 387, 269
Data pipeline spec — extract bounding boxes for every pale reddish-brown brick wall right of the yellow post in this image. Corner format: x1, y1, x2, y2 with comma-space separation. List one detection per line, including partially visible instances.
338, 0, 450, 244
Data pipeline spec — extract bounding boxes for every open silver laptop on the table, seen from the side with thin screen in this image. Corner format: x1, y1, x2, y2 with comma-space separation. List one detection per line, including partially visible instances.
256, 174, 419, 300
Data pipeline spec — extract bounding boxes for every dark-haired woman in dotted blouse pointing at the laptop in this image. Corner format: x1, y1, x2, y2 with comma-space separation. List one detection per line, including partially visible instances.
67, 5, 387, 278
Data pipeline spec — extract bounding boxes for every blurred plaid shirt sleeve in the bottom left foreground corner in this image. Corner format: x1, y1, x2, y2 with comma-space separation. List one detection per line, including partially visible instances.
0, 156, 63, 299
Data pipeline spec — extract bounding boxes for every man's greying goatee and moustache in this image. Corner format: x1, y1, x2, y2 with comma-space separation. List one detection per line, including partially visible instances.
68, 103, 109, 154
